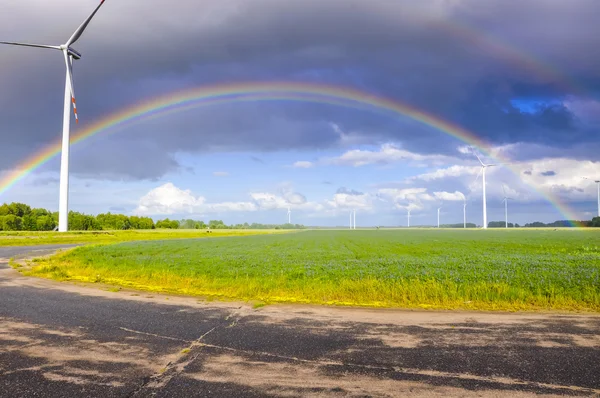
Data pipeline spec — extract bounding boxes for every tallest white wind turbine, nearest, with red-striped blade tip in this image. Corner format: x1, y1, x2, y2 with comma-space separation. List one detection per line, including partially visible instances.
0, 0, 105, 232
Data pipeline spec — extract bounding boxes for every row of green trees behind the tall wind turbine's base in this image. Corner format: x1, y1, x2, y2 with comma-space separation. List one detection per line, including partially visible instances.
0, 202, 305, 231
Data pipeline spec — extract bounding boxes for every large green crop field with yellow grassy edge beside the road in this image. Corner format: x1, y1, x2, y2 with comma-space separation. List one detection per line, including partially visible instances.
22, 229, 600, 311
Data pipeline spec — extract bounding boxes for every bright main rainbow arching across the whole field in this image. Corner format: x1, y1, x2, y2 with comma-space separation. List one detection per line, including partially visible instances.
0, 82, 576, 224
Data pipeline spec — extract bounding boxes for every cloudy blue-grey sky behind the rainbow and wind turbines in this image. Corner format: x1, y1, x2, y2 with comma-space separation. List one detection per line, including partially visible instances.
0, 0, 600, 227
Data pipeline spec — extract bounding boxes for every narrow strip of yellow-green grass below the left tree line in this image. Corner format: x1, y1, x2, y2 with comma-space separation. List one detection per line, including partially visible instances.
0, 229, 289, 247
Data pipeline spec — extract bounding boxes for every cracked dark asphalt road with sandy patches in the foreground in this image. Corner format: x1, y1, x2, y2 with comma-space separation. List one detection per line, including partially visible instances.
0, 246, 600, 398
